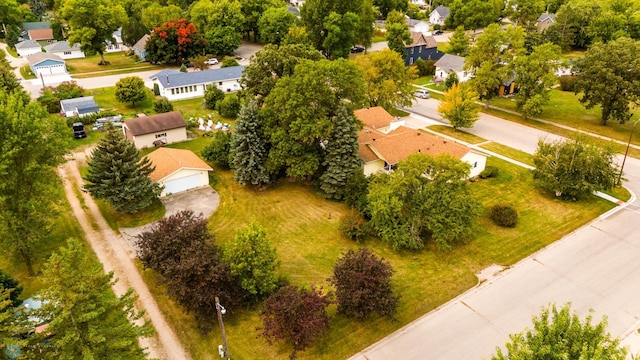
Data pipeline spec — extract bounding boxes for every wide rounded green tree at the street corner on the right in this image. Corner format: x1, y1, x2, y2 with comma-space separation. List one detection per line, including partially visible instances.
533, 137, 620, 200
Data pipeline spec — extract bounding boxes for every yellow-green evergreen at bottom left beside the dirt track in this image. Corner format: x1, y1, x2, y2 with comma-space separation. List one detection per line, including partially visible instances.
39, 240, 152, 360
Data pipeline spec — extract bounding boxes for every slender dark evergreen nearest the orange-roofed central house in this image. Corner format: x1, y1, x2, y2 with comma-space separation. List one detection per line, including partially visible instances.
320, 106, 362, 199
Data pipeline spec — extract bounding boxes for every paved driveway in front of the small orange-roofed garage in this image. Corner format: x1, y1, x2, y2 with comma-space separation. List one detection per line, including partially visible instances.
120, 186, 220, 250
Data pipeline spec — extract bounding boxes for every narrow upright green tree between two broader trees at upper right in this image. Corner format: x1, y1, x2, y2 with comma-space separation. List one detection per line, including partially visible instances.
514, 43, 560, 118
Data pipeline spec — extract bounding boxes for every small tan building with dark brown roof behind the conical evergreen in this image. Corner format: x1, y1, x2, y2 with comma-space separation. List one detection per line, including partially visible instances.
122, 111, 187, 149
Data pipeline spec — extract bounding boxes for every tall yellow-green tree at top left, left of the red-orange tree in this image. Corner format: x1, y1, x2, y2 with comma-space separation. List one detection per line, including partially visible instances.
60, 0, 127, 64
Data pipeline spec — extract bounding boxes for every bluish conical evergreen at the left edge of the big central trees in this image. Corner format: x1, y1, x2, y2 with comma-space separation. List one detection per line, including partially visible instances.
231, 101, 269, 185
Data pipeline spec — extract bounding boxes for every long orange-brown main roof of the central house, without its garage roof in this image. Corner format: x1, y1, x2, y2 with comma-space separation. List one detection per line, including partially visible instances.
358, 126, 471, 165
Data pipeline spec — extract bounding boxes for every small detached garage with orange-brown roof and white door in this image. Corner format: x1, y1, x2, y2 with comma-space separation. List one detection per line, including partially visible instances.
147, 148, 213, 197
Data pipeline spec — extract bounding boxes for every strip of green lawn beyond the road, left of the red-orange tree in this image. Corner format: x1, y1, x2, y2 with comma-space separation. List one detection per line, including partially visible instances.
66, 52, 165, 76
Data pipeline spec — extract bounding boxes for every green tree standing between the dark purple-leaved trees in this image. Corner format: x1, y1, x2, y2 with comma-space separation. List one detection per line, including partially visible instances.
224, 223, 279, 301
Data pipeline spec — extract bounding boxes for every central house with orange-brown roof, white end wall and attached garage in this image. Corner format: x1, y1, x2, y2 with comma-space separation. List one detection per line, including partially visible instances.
354, 107, 487, 177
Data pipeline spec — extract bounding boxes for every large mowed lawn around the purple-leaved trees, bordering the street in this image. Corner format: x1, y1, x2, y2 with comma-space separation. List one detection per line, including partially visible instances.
140, 138, 613, 359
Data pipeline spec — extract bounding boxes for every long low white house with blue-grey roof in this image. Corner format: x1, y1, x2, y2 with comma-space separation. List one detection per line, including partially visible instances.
149, 66, 244, 101
